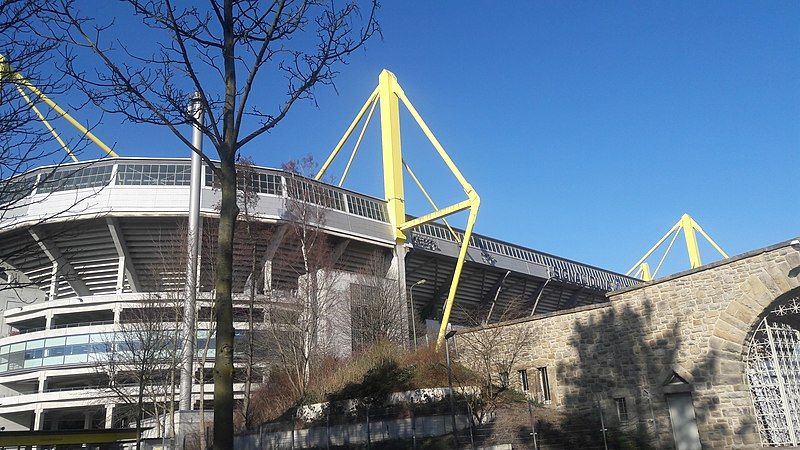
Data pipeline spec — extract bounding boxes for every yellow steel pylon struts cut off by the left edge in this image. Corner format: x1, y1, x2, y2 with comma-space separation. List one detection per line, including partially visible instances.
0, 55, 119, 162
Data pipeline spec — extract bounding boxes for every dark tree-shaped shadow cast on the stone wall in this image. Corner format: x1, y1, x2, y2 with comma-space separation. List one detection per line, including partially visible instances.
537, 301, 681, 448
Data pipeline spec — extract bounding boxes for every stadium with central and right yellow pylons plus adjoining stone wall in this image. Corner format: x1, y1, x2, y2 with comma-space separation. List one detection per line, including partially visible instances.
0, 71, 800, 449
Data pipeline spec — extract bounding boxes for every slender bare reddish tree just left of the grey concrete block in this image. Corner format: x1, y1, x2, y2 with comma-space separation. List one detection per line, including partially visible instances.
265, 158, 342, 399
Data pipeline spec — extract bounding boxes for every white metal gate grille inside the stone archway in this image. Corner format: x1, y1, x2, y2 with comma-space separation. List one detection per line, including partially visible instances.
746, 298, 800, 446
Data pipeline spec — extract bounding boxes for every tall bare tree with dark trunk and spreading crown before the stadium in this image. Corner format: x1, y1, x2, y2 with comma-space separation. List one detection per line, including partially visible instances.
44, 0, 378, 449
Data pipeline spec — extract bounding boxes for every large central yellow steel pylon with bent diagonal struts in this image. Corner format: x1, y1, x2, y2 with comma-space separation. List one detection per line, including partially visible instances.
316, 70, 481, 349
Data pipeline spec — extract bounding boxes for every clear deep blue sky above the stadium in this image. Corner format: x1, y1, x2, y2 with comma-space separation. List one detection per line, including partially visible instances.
53, 1, 800, 271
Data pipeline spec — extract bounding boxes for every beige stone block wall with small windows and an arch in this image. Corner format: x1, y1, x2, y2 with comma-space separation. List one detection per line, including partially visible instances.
459, 237, 800, 449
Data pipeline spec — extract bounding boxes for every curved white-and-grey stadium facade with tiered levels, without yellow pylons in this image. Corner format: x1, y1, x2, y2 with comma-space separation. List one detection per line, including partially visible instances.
0, 158, 639, 436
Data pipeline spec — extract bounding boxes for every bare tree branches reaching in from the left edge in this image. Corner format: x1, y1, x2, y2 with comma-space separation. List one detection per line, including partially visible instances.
0, 0, 110, 302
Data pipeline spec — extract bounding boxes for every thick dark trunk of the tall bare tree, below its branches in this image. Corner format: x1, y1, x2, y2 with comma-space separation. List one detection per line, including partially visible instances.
214, 152, 239, 450
